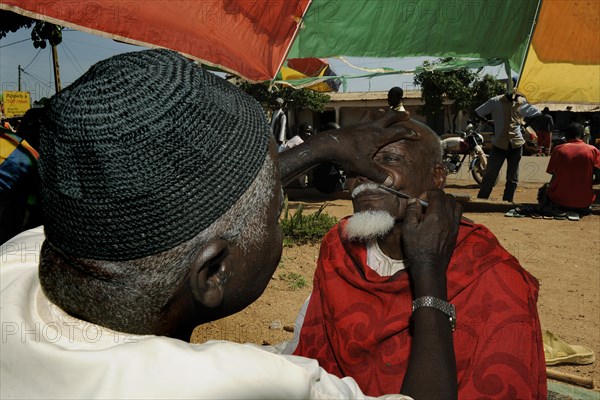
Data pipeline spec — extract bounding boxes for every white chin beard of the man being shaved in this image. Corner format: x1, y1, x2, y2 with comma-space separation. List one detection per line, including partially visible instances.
344, 210, 396, 242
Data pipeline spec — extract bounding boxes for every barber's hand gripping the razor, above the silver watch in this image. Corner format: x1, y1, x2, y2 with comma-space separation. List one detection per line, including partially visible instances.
402, 189, 462, 298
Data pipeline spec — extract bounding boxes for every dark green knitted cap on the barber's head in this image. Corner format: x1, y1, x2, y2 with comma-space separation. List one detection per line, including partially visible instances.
40, 50, 269, 260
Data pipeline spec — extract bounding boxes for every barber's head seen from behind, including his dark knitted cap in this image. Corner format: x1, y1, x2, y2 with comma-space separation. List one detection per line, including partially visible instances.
40, 50, 281, 337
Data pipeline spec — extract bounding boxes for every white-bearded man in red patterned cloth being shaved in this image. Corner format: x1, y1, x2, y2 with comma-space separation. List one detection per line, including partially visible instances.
286, 120, 547, 399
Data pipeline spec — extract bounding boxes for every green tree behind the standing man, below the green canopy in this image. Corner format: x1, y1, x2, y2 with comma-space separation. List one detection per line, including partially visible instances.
413, 58, 505, 131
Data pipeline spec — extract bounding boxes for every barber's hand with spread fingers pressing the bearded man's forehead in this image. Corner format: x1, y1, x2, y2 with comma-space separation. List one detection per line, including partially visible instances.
321, 110, 414, 186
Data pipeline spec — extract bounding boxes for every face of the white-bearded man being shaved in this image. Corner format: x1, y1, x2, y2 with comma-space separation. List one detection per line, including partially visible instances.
347, 121, 445, 220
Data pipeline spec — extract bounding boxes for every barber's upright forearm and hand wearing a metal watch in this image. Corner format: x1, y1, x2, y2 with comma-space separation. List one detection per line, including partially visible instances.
400, 190, 462, 399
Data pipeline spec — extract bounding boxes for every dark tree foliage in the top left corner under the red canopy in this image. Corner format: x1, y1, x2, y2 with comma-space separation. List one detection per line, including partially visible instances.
0, 10, 62, 49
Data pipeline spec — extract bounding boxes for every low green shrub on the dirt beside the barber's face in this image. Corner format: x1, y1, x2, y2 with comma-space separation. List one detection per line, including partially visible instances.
279, 197, 338, 247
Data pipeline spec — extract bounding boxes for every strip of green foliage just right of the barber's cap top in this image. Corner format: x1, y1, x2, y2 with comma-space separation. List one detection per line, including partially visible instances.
239, 82, 330, 112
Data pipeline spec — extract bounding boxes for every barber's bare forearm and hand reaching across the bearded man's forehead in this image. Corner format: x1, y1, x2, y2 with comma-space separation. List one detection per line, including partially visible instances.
279, 111, 411, 185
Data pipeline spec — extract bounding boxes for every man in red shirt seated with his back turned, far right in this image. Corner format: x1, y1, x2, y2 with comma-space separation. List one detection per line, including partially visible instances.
546, 123, 600, 215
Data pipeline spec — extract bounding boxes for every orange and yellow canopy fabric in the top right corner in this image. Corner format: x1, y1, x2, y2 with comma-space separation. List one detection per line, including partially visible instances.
519, 0, 600, 107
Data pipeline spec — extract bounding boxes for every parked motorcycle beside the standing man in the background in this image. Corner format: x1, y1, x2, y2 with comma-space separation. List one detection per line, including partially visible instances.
442, 123, 488, 185
